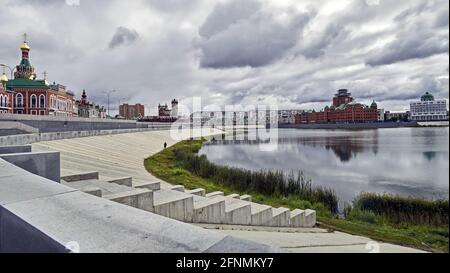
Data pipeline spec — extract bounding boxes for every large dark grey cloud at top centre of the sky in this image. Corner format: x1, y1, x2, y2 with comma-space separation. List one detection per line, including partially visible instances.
197, 0, 311, 68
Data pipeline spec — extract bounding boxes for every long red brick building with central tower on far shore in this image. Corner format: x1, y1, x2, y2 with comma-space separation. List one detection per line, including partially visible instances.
295, 89, 378, 124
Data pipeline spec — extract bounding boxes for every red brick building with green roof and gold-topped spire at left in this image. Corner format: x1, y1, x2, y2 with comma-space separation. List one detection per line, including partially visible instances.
5, 34, 75, 117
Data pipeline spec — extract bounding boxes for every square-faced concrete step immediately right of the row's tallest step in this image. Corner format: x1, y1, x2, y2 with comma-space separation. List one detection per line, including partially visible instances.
193, 195, 225, 224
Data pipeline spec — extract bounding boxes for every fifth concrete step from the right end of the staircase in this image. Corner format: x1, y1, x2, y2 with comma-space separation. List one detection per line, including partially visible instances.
211, 196, 252, 225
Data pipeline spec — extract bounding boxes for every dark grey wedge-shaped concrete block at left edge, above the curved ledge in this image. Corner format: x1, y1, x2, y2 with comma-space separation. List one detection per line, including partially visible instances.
0, 152, 61, 183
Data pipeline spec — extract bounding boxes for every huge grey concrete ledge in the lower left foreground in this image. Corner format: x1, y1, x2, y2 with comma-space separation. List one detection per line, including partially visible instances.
0, 189, 274, 253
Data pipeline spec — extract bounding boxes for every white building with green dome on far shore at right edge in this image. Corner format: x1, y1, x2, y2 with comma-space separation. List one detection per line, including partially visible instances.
410, 92, 448, 121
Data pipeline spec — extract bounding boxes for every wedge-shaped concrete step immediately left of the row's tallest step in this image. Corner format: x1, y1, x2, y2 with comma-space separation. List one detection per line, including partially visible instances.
103, 189, 153, 212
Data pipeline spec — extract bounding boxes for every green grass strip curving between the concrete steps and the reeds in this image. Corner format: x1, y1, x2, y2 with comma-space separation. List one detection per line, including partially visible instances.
144, 140, 449, 252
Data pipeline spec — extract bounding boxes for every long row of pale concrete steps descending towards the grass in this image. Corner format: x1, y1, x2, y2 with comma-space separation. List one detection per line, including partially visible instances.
61, 172, 316, 228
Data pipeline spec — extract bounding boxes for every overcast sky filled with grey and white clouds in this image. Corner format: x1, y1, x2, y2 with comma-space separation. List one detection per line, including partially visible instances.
0, 0, 449, 114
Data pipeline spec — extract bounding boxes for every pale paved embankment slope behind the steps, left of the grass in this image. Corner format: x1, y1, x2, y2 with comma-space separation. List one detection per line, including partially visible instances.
33, 126, 221, 189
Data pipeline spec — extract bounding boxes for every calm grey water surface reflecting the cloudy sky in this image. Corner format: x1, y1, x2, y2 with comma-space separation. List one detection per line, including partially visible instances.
200, 128, 449, 200
